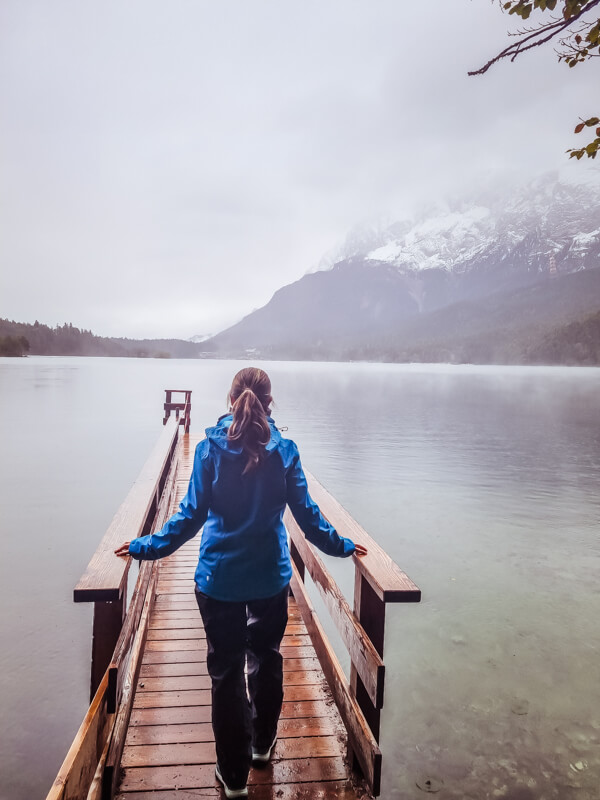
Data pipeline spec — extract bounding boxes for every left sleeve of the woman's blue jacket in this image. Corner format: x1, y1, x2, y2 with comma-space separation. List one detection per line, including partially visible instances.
129, 439, 212, 561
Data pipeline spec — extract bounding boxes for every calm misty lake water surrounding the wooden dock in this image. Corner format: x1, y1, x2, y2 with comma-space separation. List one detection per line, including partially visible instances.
0, 357, 600, 800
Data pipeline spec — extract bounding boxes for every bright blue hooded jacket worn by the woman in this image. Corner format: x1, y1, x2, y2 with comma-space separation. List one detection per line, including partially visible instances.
129, 415, 355, 601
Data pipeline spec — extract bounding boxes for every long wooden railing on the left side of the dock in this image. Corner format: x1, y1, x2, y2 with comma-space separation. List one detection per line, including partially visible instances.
47, 390, 184, 800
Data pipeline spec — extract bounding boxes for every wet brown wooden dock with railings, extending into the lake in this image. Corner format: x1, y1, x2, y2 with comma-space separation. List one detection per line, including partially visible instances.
48, 393, 420, 800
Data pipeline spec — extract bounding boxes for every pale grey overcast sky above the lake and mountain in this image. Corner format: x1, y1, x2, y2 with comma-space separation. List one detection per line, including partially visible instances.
0, 0, 600, 338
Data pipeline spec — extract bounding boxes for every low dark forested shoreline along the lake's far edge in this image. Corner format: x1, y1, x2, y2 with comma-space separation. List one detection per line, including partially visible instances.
0, 312, 600, 366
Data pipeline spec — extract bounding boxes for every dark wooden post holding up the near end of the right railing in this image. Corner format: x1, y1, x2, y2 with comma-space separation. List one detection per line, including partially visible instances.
350, 569, 385, 795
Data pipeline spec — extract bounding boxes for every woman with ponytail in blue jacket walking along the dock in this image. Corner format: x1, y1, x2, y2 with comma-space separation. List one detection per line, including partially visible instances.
115, 367, 367, 798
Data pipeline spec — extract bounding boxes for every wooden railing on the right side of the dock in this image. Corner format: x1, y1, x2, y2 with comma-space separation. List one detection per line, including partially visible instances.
284, 474, 421, 796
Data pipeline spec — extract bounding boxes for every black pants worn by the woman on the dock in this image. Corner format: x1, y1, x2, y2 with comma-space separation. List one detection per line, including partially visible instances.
196, 586, 289, 789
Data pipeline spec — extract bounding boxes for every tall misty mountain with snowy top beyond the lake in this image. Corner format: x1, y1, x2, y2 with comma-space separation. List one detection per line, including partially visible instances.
206, 176, 600, 357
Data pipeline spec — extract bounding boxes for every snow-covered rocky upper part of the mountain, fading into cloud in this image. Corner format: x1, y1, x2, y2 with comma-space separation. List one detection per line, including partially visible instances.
333, 175, 600, 273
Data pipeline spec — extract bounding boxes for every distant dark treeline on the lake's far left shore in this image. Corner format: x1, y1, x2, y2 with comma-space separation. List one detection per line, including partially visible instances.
0, 319, 200, 358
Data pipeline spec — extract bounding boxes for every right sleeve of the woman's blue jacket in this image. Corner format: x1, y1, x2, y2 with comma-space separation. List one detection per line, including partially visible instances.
286, 442, 355, 558
